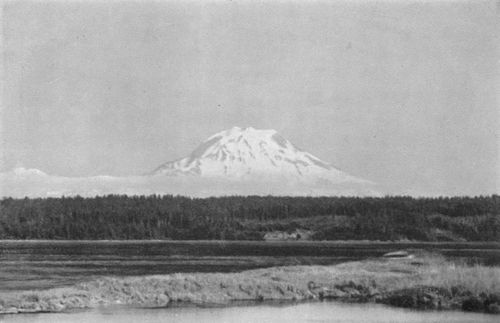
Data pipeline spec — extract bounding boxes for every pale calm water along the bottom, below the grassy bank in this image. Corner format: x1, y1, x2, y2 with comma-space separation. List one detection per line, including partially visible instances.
0, 302, 498, 323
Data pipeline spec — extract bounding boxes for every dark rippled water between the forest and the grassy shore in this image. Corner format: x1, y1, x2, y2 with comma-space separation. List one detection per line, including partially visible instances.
0, 240, 500, 291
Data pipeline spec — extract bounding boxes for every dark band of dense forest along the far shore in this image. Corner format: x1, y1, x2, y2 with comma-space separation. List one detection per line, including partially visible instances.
0, 195, 500, 241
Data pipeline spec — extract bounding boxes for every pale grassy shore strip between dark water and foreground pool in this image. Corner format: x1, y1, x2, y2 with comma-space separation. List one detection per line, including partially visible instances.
0, 254, 500, 314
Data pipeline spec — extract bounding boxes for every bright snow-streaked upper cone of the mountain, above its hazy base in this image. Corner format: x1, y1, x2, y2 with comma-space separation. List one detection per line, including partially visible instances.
152, 127, 364, 183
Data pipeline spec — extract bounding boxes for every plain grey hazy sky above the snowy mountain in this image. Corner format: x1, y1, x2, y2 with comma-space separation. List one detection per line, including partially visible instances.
0, 1, 500, 195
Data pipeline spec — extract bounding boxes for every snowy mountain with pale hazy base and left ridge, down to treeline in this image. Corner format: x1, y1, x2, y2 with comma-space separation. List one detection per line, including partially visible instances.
0, 127, 380, 197
